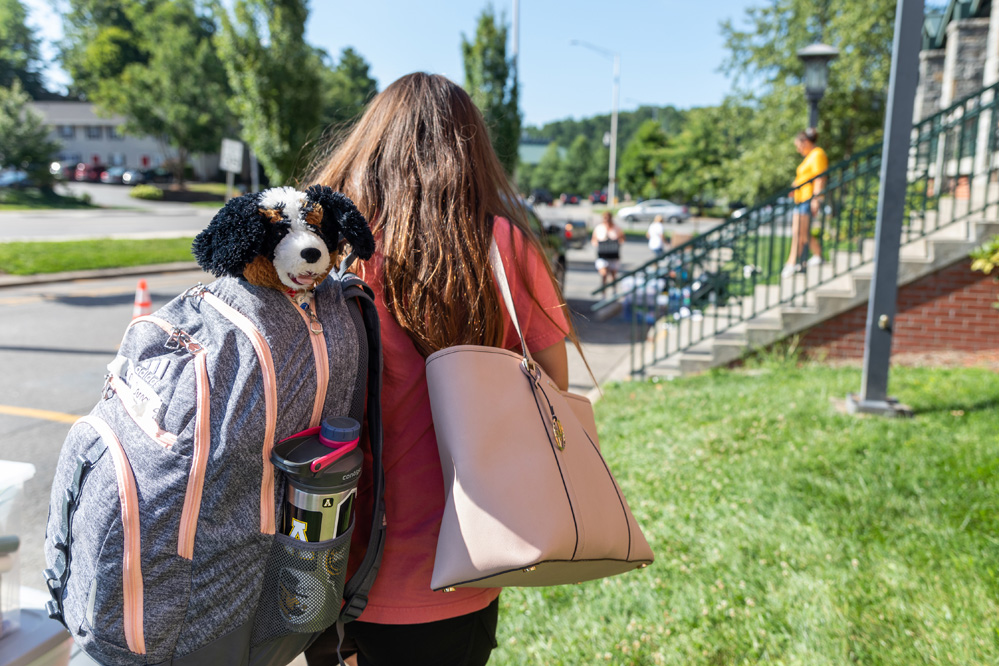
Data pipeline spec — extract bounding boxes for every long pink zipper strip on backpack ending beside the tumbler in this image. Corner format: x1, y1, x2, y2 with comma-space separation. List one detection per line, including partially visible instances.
201, 290, 277, 534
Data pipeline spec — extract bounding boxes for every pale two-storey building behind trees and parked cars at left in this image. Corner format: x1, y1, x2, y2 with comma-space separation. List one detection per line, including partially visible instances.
31, 101, 218, 180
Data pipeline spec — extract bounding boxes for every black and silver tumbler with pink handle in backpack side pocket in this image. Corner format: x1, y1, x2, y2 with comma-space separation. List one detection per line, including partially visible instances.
271, 417, 364, 541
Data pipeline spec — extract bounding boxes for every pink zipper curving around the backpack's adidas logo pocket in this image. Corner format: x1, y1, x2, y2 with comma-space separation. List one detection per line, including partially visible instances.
130, 315, 211, 560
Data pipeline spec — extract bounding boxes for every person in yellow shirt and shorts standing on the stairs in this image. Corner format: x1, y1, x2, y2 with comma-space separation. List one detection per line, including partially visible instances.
781, 127, 829, 277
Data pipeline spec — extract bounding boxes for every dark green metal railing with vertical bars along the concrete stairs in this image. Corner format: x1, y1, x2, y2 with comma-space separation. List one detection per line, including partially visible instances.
593, 84, 999, 375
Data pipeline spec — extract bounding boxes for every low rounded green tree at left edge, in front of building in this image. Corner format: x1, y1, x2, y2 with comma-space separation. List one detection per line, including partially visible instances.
0, 79, 59, 186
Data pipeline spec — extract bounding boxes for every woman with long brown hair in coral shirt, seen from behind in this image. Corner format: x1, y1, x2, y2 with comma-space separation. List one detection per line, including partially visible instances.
307, 73, 575, 666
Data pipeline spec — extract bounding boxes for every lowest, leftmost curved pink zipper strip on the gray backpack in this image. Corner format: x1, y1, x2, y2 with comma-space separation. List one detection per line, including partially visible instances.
74, 416, 146, 654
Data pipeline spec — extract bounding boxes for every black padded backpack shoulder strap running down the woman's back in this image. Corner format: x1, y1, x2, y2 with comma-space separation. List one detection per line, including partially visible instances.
339, 273, 386, 622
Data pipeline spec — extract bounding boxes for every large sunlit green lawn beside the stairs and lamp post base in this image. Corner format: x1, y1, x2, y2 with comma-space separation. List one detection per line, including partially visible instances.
490, 363, 999, 666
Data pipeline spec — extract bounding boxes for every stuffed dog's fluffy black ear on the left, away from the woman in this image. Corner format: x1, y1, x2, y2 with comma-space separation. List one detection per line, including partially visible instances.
191, 194, 267, 277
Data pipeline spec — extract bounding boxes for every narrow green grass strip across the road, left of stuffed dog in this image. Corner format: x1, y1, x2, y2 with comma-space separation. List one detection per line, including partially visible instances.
0, 238, 194, 275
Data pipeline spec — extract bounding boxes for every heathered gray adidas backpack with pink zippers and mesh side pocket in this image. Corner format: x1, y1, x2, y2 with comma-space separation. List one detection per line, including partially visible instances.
45, 274, 384, 666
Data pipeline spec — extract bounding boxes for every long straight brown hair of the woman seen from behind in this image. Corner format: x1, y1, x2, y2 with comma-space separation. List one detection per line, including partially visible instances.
308, 72, 575, 356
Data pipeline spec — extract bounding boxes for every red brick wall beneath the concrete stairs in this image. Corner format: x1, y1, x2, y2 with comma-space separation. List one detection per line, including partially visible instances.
800, 259, 999, 358
